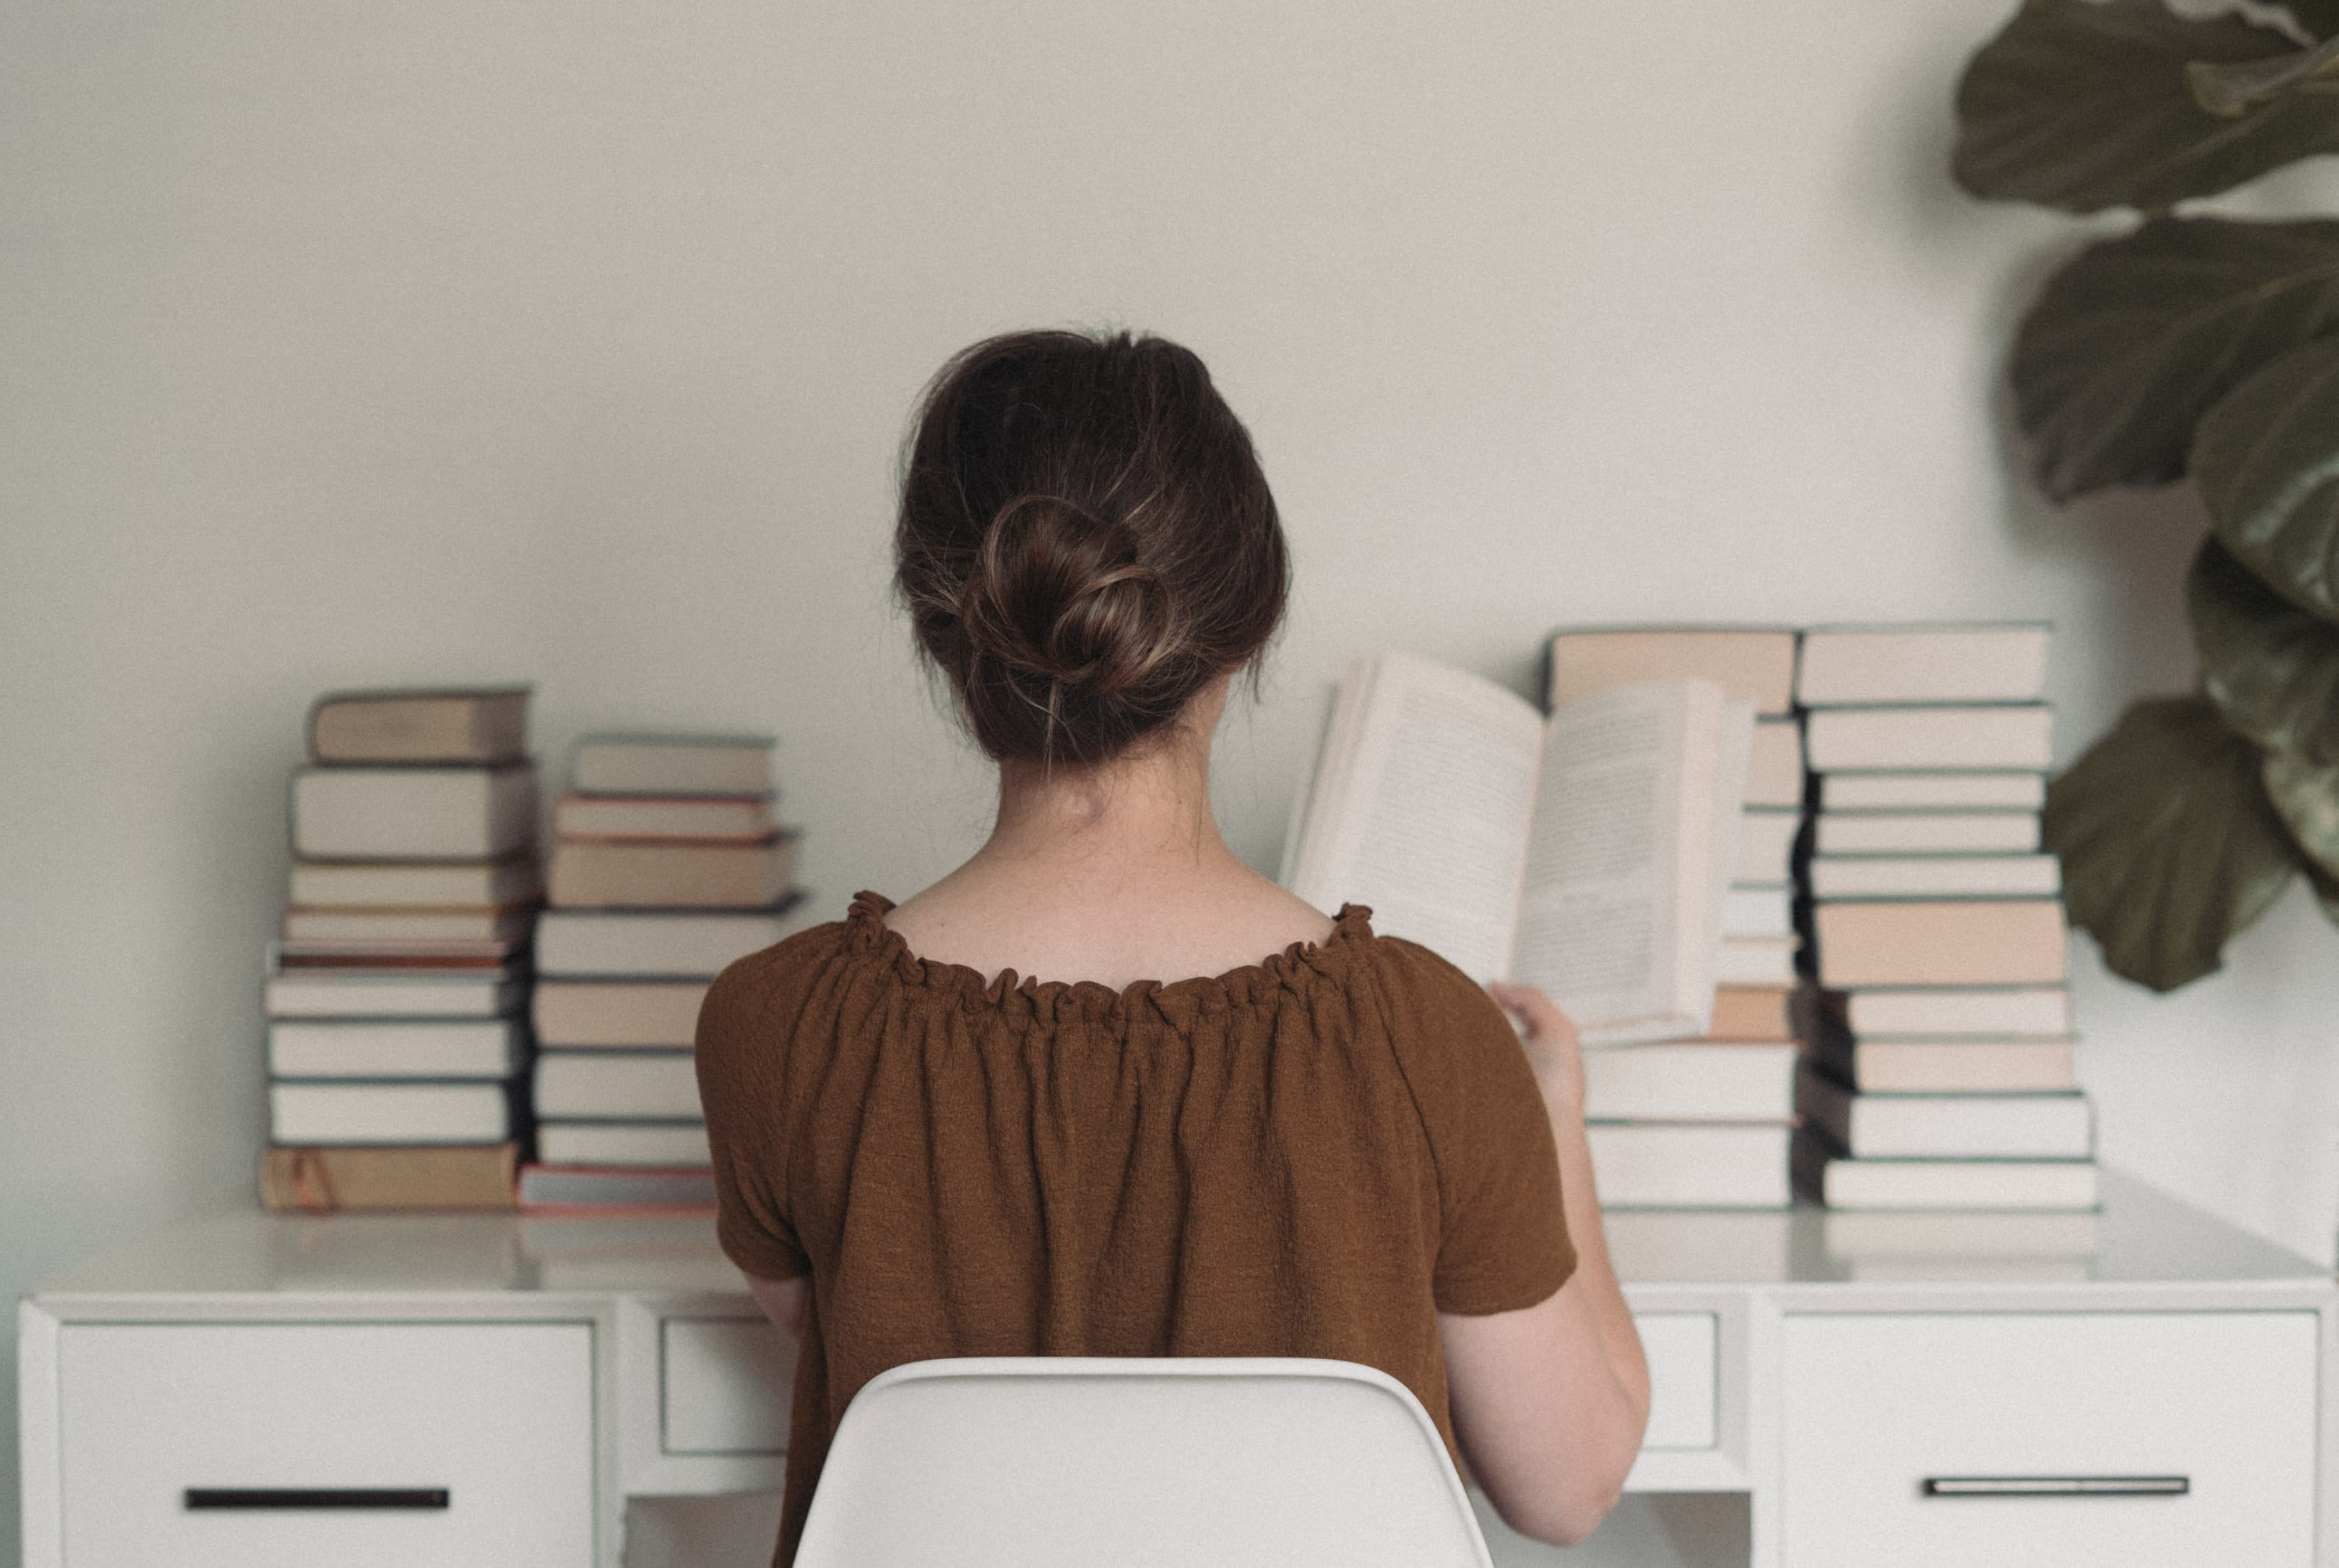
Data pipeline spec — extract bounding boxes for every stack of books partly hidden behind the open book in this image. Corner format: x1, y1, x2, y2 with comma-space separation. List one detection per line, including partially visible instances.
1546, 627, 1804, 1207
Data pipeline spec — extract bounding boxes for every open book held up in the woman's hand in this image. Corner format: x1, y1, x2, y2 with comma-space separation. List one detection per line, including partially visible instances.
1279, 653, 1754, 1044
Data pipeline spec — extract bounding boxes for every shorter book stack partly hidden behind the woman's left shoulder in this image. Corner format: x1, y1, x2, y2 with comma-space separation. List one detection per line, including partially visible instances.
519, 735, 802, 1212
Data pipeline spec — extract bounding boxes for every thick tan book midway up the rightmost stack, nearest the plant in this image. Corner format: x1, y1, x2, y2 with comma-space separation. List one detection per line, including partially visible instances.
1813, 899, 2063, 985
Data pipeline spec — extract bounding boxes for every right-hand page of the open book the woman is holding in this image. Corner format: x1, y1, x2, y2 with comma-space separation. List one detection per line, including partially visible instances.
1513, 681, 1745, 1044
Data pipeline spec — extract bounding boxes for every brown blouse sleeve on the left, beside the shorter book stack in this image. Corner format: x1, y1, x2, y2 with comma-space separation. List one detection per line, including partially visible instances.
697, 950, 811, 1280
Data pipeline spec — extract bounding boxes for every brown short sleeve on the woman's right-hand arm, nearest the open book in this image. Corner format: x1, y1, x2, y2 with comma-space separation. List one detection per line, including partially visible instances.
1380, 939, 1576, 1318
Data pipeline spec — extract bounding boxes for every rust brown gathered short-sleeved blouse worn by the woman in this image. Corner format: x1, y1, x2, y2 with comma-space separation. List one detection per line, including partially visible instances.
697, 894, 1574, 1563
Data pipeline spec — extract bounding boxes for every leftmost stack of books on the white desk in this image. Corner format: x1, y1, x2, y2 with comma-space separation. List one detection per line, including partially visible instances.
259, 688, 543, 1210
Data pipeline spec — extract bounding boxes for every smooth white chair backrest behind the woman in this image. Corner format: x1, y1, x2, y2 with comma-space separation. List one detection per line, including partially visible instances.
796, 1357, 1490, 1568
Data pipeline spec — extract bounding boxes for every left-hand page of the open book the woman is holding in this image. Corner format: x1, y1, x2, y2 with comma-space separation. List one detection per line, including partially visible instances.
1289, 653, 1542, 981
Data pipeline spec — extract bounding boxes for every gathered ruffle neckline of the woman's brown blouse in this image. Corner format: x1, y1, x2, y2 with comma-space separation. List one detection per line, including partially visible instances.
844, 889, 1373, 1013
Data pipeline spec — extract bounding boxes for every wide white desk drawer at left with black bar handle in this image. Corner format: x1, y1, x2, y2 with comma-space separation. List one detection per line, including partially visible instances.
58, 1323, 594, 1568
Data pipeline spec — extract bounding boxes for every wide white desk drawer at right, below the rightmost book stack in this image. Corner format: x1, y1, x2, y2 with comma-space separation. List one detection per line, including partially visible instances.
1782, 1313, 2316, 1568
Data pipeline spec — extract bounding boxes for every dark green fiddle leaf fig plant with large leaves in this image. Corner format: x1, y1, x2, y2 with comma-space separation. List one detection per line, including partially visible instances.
1953, 0, 2339, 990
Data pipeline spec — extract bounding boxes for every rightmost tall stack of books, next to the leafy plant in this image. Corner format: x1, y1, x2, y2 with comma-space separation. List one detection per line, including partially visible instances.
1796, 625, 2096, 1210
